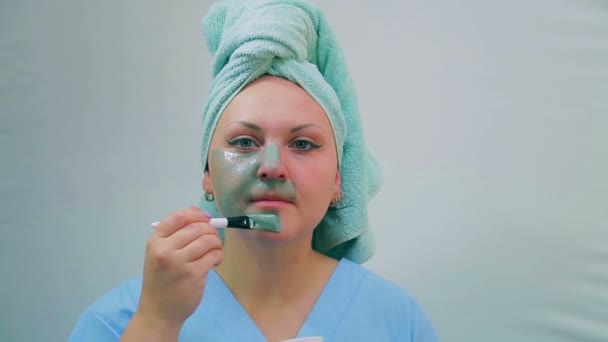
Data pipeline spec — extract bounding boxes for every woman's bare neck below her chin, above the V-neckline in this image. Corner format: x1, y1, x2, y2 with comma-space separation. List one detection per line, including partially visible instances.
216, 232, 335, 307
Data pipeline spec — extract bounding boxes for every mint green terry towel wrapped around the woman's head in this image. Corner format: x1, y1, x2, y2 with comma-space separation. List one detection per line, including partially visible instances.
201, 0, 382, 263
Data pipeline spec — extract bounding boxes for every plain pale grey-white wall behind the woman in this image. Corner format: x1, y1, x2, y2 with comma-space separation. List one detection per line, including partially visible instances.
0, 0, 608, 342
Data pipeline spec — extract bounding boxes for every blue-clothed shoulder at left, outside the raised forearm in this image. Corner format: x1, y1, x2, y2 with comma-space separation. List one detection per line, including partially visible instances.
70, 277, 142, 341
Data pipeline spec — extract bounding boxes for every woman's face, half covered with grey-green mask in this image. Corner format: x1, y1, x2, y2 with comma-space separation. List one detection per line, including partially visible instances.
203, 76, 340, 240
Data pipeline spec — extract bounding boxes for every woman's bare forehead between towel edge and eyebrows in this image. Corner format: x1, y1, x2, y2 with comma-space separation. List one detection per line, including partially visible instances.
218, 76, 331, 131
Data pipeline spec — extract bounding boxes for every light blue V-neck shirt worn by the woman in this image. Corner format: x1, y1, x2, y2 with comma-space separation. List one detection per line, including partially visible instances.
69, 259, 438, 342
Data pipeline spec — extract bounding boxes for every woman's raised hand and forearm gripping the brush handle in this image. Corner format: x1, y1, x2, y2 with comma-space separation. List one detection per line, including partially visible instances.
123, 207, 222, 340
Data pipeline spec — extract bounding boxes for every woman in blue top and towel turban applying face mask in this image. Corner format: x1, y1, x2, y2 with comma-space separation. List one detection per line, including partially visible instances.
71, 1, 437, 341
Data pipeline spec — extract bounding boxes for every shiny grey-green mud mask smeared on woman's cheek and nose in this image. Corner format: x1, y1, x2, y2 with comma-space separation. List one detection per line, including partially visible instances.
210, 144, 296, 224
